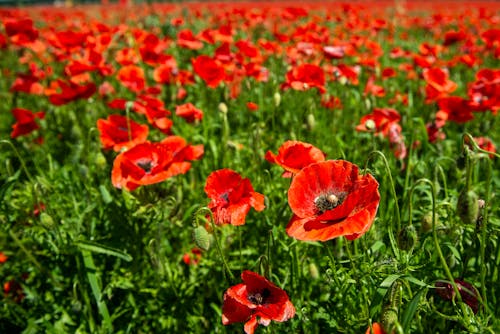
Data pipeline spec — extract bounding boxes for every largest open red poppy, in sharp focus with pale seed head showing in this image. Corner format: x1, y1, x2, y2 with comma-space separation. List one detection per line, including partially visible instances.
286, 160, 380, 241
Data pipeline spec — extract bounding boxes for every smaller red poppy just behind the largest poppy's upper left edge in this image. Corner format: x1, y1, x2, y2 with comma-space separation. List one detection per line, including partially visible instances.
265, 140, 325, 177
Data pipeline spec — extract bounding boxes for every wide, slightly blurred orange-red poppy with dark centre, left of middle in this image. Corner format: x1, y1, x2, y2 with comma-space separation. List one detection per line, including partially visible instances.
111, 136, 203, 190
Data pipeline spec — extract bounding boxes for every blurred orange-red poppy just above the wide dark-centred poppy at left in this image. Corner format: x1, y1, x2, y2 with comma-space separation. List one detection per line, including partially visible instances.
97, 115, 149, 152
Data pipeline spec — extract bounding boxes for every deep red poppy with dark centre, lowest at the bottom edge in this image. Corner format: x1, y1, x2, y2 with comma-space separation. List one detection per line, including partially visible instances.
222, 270, 295, 334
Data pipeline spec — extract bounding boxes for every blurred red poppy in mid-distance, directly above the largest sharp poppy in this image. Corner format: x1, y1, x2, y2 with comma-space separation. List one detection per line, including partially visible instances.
281, 64, 326, 93
